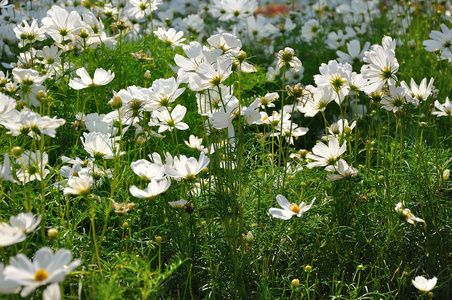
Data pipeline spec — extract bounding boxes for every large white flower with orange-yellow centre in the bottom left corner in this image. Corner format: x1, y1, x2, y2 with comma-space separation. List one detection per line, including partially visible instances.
3, 247, 81, 297
